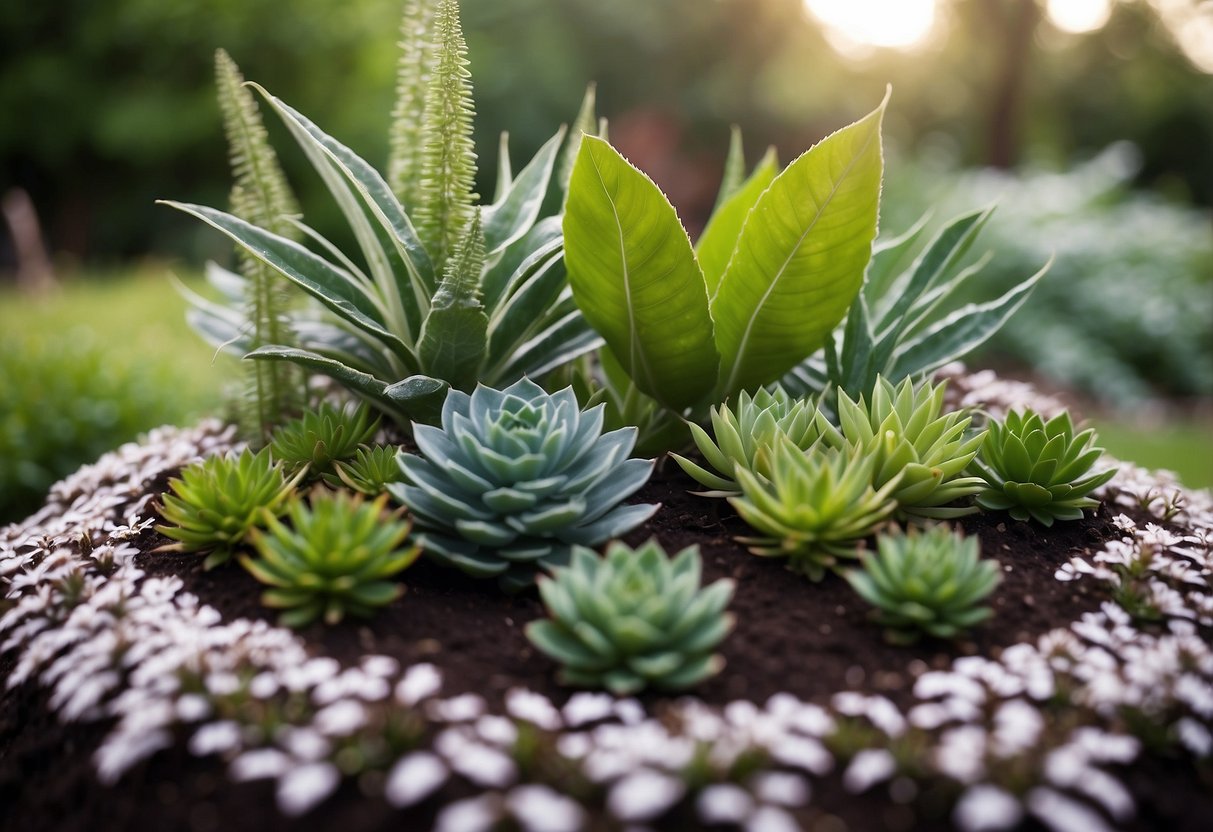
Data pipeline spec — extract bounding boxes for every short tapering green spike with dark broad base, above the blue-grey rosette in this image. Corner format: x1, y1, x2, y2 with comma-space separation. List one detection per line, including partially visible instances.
417, 211, 489, 391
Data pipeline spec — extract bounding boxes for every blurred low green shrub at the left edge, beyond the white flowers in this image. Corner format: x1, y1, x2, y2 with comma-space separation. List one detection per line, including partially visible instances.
0, 334, 193, 524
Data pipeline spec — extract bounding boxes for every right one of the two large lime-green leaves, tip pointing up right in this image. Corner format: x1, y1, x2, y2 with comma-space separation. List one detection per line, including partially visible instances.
712, 95, 888, 398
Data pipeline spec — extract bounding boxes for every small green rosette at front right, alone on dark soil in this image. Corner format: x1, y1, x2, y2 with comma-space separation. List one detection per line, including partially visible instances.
847, 526, 1002, 644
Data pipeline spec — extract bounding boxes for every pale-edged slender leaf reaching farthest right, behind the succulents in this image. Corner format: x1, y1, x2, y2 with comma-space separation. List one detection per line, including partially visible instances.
889, 258, 1053, 378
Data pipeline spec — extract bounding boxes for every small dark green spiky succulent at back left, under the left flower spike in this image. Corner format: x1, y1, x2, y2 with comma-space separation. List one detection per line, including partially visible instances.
269, 404, 378, 479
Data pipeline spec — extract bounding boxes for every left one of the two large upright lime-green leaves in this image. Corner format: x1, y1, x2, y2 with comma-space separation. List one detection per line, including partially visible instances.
564, 136, 719, 410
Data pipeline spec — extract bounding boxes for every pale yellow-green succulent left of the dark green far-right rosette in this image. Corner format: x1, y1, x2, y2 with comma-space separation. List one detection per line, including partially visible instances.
818, 376, 985, 519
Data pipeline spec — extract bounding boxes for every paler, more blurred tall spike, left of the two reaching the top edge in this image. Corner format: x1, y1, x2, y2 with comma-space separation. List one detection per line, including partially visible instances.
387, 0, 435, 208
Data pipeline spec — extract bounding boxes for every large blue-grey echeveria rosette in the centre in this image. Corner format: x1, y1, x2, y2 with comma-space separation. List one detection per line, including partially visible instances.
388, 378, 657, 589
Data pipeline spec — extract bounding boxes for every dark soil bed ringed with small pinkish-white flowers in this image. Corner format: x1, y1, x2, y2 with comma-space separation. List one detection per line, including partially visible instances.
0, 375, 1213, 831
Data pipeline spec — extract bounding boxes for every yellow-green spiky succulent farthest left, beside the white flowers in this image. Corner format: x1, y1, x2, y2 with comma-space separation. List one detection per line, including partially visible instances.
156, 449, 301, 569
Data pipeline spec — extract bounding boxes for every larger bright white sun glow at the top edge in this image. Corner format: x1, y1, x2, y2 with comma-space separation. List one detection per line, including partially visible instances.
804, 0, 936, 50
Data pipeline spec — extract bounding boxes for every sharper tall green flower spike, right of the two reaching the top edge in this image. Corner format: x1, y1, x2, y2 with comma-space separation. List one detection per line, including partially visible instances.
415, 0, 475, 268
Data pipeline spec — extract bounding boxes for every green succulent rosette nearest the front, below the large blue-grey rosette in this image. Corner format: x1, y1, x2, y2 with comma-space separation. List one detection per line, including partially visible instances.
526, 540, 733, 696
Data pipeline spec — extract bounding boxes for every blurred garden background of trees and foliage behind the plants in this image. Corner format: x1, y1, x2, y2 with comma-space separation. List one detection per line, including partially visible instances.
0, 0, 1213, 518
